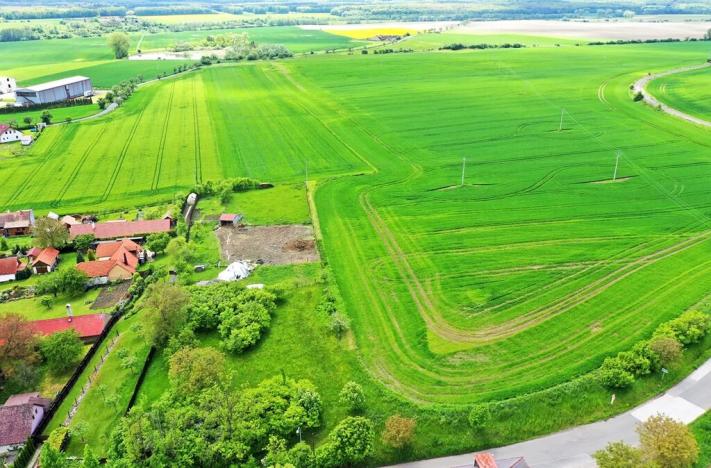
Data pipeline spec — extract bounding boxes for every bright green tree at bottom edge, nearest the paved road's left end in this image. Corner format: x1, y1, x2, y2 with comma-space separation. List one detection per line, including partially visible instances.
316, 416, 375, 466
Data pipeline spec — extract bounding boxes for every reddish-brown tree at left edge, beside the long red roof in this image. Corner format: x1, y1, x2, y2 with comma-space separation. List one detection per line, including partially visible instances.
0, 314, 38, 379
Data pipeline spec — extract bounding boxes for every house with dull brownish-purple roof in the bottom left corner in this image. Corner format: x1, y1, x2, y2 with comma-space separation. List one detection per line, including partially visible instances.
0, 392, 50, 457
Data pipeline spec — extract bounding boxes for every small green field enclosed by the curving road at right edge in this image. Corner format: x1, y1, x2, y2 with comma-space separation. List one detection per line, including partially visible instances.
647, 68, 711, 120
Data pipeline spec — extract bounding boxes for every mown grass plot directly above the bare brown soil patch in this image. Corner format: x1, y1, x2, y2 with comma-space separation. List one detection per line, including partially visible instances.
198, 184, 309, 224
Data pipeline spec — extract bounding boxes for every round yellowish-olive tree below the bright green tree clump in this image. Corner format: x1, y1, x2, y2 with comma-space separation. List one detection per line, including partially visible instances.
168, 348, 225, 394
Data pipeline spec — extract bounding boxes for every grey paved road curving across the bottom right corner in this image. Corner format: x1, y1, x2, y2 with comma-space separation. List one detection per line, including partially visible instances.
396, 359, 711, 468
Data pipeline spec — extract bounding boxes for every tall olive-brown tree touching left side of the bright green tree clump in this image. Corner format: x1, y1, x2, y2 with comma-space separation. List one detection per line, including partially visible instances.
144, 283, 190, 347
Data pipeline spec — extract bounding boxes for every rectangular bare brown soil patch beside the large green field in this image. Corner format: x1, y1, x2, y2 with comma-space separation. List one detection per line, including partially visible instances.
217, 224, 319, 265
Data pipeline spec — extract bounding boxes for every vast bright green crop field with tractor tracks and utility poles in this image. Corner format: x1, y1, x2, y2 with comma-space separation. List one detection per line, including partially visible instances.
0, 43, 711, 404
